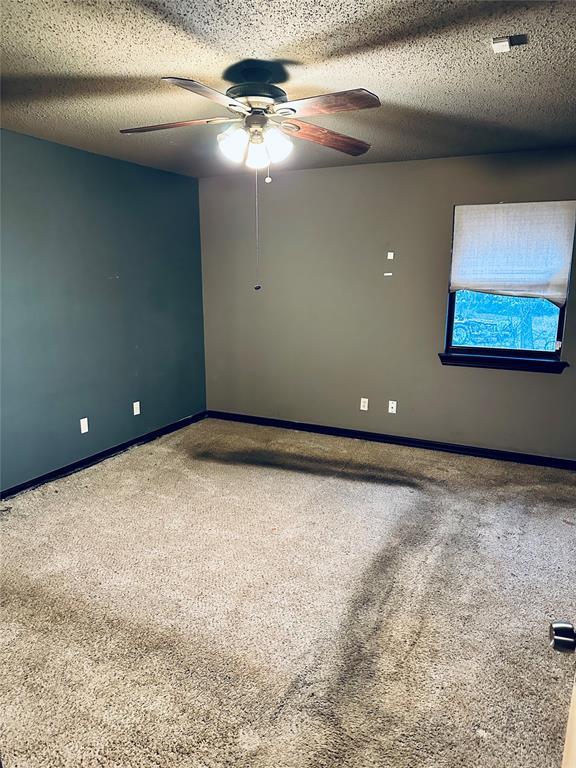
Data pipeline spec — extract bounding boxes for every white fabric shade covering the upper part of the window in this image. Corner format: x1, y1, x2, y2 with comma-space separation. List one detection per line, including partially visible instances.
450, 200, 576, 306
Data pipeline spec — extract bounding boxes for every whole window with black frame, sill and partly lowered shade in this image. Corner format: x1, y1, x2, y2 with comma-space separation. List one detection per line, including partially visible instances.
440, 201, 576, 373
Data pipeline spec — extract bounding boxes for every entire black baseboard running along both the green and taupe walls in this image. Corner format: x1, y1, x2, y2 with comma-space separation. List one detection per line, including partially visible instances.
0, 411, 576, 499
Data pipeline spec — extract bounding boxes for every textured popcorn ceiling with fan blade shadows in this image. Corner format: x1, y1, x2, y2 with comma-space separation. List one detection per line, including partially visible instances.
2, 0, 576, 176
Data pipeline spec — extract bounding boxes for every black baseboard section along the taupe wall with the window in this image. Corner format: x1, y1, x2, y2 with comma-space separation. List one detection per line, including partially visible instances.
205, 411, 576, 471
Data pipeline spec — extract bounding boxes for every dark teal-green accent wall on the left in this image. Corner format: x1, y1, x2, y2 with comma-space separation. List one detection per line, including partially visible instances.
0, 131, 205, 489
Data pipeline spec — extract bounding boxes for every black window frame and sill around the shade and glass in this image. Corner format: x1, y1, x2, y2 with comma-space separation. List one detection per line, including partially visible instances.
438, 200, 576, 373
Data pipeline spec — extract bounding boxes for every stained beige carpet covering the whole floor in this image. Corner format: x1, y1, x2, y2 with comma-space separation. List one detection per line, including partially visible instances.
0, 420, 576, 768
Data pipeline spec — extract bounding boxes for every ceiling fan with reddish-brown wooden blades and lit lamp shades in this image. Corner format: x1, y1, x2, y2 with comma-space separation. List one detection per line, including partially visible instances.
120, 77, 380, 169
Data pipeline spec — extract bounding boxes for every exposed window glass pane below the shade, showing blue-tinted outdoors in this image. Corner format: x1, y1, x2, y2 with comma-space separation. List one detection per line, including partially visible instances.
452, 291, 560, 352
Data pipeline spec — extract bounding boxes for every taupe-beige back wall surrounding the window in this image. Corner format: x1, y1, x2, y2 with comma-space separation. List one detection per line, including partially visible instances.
200, 150, 576, 458
